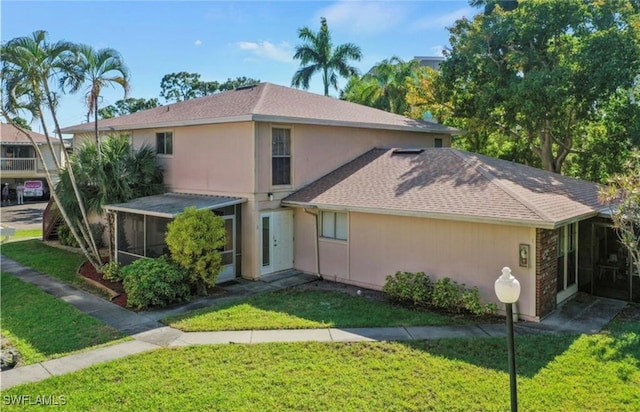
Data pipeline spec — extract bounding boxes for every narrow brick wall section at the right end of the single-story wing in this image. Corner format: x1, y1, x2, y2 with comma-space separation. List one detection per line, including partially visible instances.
536, 229, 558, 318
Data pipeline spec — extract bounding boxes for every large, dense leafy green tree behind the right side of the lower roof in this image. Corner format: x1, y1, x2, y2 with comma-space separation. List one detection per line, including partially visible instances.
437, 0, 640, 173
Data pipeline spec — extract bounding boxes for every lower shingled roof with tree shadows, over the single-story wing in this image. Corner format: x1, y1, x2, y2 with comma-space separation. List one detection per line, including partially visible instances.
283, 148, 602, 229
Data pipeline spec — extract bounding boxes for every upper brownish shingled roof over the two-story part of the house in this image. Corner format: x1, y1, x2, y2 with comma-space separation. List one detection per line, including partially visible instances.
62, 83, 459, 135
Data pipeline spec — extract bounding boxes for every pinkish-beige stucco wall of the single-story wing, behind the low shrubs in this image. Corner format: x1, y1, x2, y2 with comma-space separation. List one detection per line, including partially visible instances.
342, 213, 536, 319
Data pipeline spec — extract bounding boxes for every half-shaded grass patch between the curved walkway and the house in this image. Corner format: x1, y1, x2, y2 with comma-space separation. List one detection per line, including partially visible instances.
163, 290, 470, 332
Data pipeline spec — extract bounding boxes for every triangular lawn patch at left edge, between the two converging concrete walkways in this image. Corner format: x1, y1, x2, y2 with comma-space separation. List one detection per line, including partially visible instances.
0, 272, 123, 364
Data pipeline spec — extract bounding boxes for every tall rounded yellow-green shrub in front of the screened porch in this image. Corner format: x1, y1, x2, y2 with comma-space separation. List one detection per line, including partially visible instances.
166, 207, 226, 294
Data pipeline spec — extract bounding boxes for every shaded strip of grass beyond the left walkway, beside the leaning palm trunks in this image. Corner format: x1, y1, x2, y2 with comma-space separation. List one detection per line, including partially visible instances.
2, 239, 87, 288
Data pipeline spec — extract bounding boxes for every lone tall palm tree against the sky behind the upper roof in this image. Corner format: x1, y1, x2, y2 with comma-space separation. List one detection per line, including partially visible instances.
291, 17, 362, 96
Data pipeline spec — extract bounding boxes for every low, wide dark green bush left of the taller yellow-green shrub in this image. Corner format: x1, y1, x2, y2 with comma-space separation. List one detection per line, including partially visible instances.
122, 256, 190, 309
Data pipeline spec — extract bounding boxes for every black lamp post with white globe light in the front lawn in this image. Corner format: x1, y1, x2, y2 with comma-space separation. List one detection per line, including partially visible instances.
494, 267, 520, 412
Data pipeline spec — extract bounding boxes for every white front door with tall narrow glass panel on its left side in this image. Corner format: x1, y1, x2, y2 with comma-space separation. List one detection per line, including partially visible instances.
260, 210, 293, 275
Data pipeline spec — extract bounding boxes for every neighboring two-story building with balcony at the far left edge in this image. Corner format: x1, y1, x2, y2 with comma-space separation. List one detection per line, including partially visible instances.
0, 123, 65, 197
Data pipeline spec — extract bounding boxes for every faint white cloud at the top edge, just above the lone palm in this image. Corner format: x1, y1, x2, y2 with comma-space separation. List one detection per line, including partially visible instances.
314, 1, 408, 35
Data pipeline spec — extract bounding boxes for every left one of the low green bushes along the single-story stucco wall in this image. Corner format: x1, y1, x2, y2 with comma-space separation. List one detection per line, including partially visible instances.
382, 272, 433, 306
